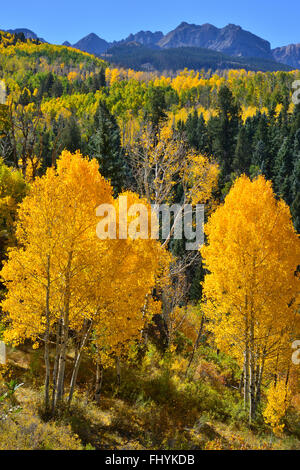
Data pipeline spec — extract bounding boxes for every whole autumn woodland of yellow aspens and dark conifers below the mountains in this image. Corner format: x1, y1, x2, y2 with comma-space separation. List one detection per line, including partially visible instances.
0, 32, 300, 449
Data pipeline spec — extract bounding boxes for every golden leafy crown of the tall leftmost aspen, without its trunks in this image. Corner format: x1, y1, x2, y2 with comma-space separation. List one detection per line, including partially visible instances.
2, 151, 112, 341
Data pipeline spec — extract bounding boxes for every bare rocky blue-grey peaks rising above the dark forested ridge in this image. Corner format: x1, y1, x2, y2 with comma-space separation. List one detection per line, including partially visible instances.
63, 22, 300, 68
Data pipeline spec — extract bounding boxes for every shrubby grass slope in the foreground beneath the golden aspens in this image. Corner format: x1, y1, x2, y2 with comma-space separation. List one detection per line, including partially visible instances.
0, 347, 300, 450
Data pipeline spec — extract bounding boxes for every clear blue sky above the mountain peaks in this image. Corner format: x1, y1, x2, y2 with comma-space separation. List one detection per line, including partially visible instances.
0, 0, 300, 47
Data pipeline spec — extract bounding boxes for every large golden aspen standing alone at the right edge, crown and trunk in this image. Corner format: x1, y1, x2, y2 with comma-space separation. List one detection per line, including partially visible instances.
202, 175, 300, 422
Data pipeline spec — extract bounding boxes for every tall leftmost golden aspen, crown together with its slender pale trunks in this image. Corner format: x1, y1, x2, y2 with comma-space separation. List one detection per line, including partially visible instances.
2, 152, 112, 408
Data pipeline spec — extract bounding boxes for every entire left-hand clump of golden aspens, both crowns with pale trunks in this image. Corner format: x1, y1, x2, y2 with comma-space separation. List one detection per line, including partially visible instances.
1, 151, 170, 412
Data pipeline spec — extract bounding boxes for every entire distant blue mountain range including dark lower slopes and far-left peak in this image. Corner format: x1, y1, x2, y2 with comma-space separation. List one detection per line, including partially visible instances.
2, 22, 300, 70
